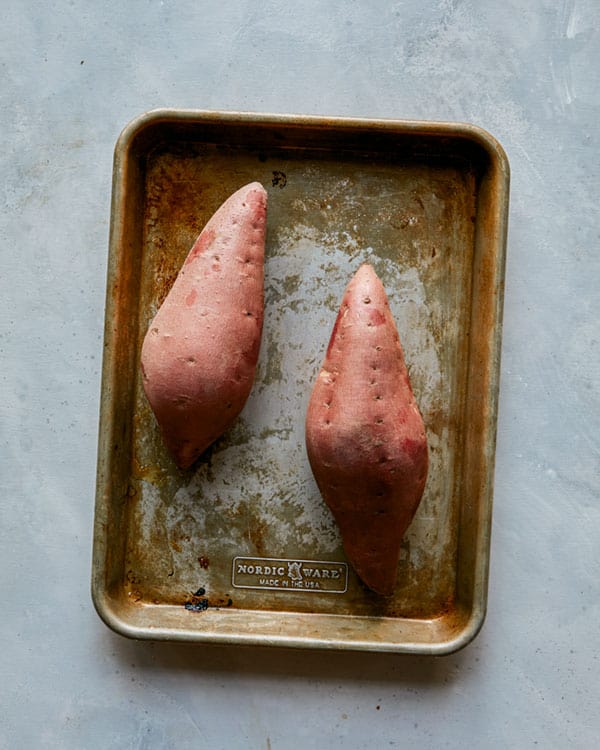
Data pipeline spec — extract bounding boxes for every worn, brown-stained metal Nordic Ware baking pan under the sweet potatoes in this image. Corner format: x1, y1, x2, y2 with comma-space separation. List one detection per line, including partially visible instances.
92, 110, 509, 654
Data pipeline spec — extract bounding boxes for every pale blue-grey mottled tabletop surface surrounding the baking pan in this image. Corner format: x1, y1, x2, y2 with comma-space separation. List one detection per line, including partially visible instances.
0, 0, 600, 750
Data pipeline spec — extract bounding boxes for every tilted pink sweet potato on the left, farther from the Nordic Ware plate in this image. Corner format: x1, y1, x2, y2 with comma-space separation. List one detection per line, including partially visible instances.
141, 182, 267, 469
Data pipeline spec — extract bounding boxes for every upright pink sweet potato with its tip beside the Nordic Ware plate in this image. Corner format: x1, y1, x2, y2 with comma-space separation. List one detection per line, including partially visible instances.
306, 264, 428, 596
